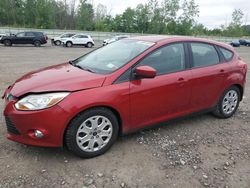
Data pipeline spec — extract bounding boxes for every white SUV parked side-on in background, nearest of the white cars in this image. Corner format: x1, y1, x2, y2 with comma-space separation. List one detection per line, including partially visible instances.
62, 34, 95, 48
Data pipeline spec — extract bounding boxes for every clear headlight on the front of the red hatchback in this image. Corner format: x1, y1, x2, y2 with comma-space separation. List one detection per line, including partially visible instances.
15, 92, 69, 110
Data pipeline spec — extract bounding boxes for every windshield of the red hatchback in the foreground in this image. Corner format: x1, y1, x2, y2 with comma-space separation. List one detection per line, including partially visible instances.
72, 39, 154, 74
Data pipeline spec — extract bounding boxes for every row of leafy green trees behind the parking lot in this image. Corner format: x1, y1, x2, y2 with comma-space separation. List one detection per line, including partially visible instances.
0, 0, 250, 37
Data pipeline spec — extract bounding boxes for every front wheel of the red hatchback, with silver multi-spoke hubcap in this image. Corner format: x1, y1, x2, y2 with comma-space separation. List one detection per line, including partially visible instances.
64, 108, 119, 158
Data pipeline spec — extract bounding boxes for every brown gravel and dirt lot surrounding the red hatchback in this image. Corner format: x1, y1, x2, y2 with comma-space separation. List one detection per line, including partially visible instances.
0, 45, 250, 188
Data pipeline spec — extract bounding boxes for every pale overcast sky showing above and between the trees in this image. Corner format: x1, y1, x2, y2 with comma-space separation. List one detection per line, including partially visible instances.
92, 0, 250, 28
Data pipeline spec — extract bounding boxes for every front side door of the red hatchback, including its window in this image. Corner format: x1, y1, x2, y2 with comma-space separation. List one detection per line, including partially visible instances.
130, 43, 191, 128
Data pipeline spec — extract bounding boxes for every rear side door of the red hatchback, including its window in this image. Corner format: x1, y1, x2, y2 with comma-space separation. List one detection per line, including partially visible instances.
189, 42, 230, 110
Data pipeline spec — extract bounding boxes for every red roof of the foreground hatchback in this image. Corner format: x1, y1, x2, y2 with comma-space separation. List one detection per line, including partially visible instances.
129, 35, 233, 50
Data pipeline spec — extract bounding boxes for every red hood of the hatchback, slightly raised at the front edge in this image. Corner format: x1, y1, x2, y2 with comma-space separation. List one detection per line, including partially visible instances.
10, 63, 106, 97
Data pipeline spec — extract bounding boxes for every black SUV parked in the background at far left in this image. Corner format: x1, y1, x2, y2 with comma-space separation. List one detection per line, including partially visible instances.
0, 31, 48, 46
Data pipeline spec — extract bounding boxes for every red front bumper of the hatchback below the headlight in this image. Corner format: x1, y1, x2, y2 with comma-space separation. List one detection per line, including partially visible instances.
4, 101, 69, 147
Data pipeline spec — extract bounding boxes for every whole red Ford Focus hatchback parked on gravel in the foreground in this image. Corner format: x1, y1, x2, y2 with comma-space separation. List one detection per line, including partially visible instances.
4, 36, 247, 157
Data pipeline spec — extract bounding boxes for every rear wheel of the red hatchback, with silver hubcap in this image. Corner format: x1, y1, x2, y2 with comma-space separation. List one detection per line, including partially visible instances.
213, 86, 240, 118
